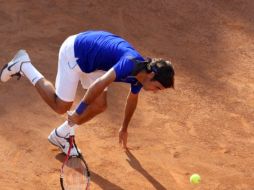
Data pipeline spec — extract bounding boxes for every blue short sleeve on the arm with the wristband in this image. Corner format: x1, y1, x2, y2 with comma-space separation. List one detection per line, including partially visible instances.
113, 57, 134, 81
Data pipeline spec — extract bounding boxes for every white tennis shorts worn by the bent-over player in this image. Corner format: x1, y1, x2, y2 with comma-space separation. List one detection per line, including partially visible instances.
55, 35, 107, 102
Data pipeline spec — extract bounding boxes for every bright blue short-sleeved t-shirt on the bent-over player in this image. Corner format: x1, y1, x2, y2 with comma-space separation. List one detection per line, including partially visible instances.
74, 31, 144, 93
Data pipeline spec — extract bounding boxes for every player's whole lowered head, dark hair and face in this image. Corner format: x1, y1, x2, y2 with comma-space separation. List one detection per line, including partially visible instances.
135, 58, 175, 91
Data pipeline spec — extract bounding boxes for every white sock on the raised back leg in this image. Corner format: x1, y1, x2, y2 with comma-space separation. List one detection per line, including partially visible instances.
21, 63, 44, 85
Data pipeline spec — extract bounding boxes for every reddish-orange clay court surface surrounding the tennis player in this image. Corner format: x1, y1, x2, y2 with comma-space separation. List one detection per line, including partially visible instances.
0, 0, 254, 190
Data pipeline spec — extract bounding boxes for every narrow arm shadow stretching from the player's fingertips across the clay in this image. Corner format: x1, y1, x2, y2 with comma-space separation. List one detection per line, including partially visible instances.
125, 150, 166, 190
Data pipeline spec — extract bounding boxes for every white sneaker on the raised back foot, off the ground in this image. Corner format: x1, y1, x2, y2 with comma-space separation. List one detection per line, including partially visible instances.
0, 50, 31, 82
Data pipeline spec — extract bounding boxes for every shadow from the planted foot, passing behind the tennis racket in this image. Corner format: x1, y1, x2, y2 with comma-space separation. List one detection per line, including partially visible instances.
55, 153, 124, 190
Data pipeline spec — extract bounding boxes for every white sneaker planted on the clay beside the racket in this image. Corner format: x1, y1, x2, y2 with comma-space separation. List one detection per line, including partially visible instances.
48, 129, 80, 156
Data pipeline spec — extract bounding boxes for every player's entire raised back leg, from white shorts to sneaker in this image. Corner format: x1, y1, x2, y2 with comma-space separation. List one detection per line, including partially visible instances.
0, 36, 81, 114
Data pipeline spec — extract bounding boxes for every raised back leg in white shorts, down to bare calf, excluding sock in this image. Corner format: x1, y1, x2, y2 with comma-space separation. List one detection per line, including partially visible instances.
35, 33, 82, 114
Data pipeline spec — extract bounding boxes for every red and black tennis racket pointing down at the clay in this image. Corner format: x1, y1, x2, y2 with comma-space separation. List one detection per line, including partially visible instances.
60, 127, 90, 190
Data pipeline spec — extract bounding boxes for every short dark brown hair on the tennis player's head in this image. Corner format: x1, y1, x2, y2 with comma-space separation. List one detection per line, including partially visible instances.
146, 58, 175, 88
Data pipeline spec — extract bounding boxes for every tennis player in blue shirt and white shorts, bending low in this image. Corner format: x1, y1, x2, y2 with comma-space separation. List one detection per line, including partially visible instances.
0, 31, 175, 155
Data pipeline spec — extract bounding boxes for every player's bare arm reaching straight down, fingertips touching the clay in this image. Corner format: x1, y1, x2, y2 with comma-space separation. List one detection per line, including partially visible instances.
119, 90, 138, 148
